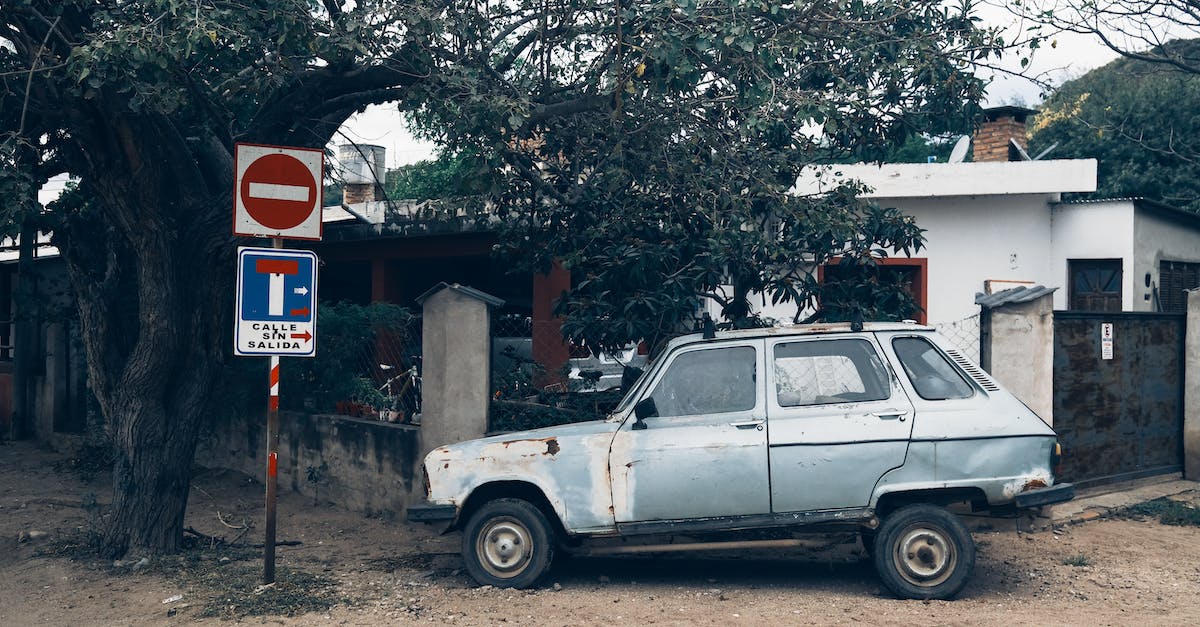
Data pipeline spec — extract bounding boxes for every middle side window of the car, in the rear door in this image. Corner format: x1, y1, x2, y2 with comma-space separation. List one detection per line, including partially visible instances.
774, 339, 892, 407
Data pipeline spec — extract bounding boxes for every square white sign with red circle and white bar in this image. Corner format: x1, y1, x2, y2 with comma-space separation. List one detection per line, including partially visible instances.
233, 144, 325, 239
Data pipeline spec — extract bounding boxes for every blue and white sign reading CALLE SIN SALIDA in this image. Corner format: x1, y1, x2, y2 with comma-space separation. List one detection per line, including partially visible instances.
234, 246, 317, 357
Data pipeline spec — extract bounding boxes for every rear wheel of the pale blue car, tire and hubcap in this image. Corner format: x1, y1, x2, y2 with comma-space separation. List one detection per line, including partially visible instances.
874, 503, 976, 599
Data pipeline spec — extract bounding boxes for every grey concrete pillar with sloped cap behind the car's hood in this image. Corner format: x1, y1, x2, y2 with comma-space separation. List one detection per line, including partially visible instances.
416, 283, 504, 462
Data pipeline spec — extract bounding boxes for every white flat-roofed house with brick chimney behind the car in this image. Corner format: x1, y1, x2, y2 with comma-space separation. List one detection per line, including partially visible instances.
782, 107, 1200, 324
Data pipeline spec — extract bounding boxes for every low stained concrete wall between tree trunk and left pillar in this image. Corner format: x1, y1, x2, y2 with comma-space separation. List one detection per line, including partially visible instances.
196, 412, 422, 516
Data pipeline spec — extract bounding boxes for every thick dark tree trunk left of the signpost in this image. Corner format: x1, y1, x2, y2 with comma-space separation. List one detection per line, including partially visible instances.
56, 109, 235, 557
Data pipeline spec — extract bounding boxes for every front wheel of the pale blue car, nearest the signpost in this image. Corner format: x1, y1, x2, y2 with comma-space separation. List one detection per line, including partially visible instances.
462, 498, 554, 587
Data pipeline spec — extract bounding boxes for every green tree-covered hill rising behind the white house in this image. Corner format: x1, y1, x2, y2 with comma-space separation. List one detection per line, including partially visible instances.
1030, 40, 1200, 210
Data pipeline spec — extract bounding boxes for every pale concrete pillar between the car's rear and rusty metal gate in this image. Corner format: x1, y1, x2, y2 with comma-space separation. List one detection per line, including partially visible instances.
983, 294, 1054, 426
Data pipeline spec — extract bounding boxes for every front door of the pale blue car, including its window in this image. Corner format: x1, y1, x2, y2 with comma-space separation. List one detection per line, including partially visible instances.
610, 340, 770, 523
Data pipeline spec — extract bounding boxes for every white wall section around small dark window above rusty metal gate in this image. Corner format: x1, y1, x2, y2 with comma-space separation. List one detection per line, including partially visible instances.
1043, 201, 1145, 311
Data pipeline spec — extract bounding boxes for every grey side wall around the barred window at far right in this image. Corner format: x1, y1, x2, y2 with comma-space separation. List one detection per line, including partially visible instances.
1130, 209, 1200, 311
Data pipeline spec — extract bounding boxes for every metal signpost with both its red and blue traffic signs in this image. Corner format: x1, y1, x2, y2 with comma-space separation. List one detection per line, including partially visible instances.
233, 144, 325, 584
